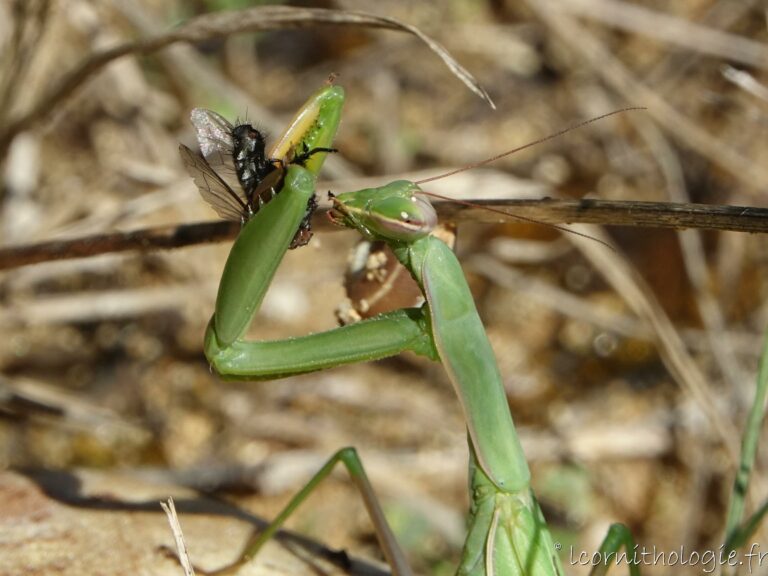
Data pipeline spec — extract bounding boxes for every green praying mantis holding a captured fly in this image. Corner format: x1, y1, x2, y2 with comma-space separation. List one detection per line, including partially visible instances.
182, 85, 629, 576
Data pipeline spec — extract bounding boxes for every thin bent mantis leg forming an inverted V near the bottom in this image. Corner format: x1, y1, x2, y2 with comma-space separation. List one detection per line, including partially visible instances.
198, 447, 412, 576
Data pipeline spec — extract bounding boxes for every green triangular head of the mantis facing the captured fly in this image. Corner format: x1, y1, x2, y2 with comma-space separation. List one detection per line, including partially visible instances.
328, 180, 437, 242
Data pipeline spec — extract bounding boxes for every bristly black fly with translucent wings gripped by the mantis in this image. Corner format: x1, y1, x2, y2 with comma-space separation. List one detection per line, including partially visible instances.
179, 108, 331, 248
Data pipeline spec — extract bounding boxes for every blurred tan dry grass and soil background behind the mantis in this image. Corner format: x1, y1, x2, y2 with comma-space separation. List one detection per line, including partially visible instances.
0, 0, 768, 574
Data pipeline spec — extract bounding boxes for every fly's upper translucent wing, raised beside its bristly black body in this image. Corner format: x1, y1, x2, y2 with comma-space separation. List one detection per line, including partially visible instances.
190, 108, 247, 202
